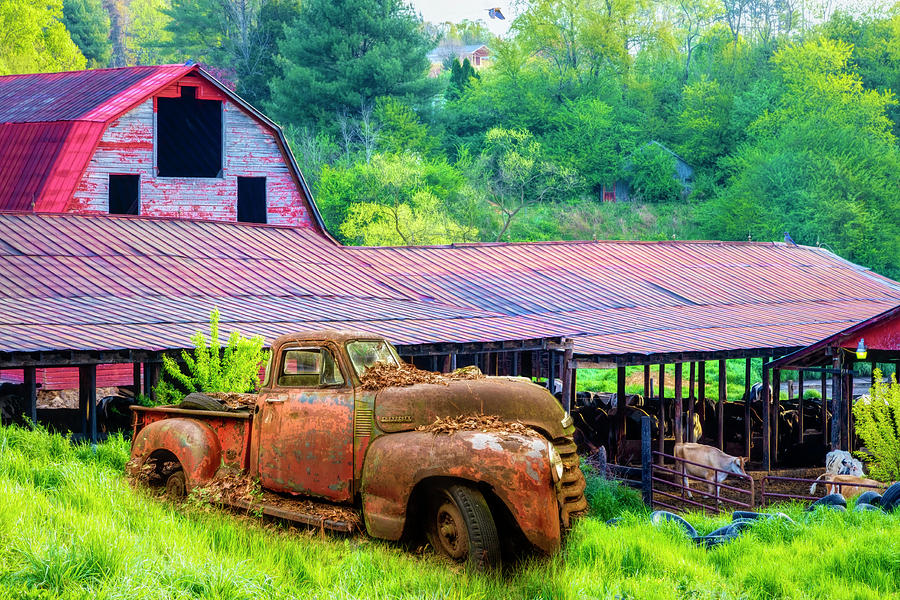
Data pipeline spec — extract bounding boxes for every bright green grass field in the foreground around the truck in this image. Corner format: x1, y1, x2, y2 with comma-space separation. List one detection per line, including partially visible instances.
0, 428, 900, 599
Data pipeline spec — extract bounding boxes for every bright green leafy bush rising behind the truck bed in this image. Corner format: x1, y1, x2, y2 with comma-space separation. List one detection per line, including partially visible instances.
155, 309, 268, 404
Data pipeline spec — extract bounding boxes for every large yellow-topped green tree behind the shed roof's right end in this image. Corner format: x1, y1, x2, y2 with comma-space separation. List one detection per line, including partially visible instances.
704, 39, 900, 274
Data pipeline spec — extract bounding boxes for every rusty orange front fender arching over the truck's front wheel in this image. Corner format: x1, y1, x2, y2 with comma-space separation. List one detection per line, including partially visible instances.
361, 431, 560, 554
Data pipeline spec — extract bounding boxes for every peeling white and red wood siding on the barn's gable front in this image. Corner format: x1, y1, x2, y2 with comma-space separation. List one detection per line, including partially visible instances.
68, 99, 313, 227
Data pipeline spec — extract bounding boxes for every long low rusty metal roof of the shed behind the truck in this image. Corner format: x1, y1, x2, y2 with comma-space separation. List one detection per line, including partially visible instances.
0, 213, 900, 356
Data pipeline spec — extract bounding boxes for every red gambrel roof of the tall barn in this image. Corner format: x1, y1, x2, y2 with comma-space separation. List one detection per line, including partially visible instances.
0, 65, 192, 211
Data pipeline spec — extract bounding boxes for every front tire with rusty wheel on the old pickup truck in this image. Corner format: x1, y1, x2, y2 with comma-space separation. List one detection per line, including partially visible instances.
425, 484, 500, 570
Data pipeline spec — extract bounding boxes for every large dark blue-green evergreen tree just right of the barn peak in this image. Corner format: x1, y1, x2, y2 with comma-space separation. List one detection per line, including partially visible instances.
269, 0, 433, 127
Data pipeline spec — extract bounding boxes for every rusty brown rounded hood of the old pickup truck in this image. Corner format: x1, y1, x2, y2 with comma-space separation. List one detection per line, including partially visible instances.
375, 377, 574, 439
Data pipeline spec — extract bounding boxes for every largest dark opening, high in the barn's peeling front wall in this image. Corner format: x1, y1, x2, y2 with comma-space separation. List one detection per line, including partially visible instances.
156, 87, 222, 177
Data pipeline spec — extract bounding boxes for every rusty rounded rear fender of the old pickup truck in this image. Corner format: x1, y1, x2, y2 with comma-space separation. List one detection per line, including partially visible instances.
131, 418, 222, 490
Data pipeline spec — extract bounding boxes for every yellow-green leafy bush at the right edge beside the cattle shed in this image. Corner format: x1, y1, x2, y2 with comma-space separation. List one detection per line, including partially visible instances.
853, 369, 900, 481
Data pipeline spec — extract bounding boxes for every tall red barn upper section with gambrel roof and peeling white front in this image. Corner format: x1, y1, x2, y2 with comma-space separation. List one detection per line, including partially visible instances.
0, 65, 327, 230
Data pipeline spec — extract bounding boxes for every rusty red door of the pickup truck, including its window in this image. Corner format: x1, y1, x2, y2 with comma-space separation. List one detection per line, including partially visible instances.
258, 345, 353, 502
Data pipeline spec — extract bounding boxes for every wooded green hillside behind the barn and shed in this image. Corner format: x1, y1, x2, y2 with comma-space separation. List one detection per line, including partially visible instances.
0, 0, 900, 277
